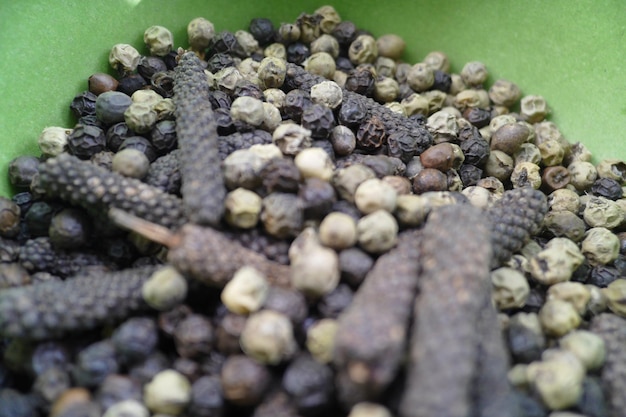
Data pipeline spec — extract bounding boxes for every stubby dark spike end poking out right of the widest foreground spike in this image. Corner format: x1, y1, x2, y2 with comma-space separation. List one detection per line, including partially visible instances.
487, 187, 548, 268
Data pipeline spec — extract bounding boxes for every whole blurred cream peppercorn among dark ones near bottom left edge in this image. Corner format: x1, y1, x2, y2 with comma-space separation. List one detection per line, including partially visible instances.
143, 369, 191, 416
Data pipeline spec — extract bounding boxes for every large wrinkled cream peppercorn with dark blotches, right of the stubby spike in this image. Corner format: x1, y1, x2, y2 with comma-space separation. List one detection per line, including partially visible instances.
529, 238, 585, 285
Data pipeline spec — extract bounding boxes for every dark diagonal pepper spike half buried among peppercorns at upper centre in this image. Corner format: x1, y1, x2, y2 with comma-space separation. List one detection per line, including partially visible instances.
285, 63, 433, 155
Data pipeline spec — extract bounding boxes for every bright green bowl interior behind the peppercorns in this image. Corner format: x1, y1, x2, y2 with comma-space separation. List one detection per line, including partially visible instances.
0, 0, 626, 196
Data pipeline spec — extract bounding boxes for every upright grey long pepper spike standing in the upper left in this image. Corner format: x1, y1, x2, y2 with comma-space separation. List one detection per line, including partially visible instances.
174, 52, 226, 225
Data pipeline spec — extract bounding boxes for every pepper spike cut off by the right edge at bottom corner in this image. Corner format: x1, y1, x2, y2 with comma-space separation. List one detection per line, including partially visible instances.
590, 313, 626, 417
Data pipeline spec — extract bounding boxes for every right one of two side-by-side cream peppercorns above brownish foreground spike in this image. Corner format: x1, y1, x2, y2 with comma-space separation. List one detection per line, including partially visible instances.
356, 210, 398, 253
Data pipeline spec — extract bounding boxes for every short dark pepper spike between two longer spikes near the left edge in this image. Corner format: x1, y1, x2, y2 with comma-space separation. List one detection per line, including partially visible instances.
19, 237, 112, 277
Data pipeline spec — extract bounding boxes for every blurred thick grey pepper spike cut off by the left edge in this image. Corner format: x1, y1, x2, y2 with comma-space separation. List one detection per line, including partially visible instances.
0, 266, 159, 340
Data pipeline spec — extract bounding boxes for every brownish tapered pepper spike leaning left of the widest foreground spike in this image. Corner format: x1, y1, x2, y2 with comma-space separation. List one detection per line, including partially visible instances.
333, 231, 420, 406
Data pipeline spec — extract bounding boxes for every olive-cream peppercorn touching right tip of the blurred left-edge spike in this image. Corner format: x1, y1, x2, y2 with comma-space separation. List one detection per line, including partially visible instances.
141, 266, 187, 311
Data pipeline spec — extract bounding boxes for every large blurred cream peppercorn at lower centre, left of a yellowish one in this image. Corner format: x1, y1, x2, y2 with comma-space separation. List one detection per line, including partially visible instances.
239, 310, 297, 365
